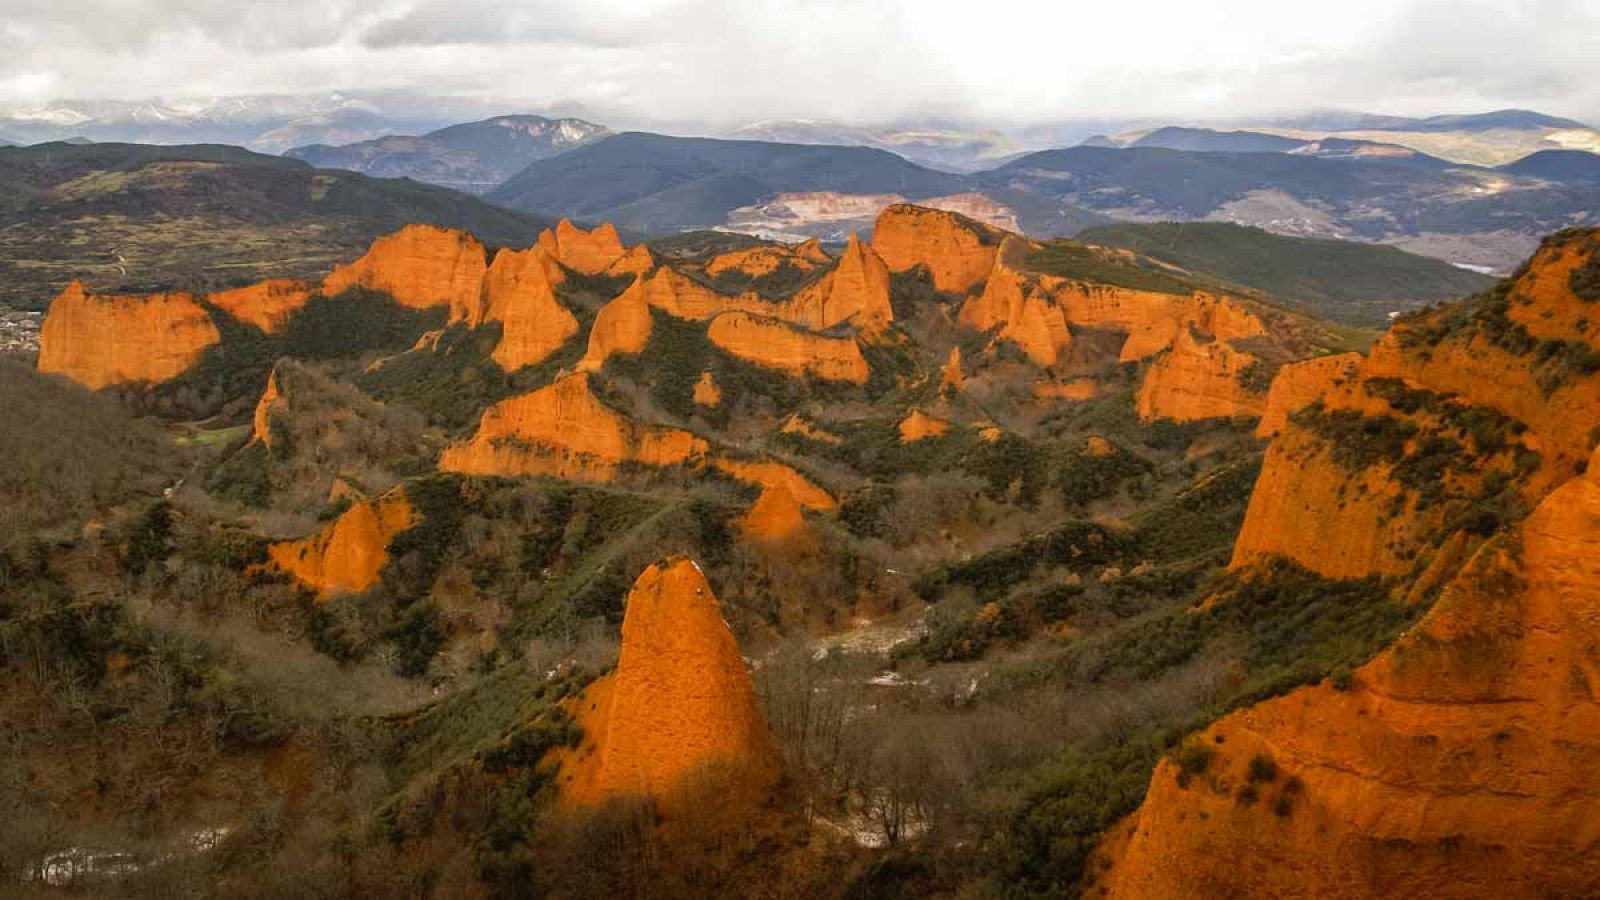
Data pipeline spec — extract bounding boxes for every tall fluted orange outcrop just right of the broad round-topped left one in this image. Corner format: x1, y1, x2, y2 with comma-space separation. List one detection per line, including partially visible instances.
469, 247, 578, 372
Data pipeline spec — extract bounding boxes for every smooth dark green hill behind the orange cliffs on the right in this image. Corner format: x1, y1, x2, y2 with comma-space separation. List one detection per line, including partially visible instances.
1078, 223, 1494, 325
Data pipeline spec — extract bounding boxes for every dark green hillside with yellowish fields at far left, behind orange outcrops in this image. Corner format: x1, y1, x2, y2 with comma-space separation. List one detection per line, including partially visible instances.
0, 143, 546, 309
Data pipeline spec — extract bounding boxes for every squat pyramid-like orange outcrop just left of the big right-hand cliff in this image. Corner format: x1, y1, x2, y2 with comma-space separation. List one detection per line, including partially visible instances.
1134, 328, 1267, 421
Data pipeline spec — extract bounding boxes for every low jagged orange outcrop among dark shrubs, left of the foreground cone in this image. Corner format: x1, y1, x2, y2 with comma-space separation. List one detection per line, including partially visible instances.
267, 488, 418, 601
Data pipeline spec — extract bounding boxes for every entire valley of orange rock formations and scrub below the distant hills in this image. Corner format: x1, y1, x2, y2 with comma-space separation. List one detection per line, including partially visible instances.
0, 175, 1600, 897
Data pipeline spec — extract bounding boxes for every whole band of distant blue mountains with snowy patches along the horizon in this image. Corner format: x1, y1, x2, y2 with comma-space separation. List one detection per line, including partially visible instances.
0, 93, 1600, 271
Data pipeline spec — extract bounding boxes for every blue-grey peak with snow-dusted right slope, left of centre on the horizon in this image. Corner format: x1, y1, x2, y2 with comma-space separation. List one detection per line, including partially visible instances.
283, 115, 611, 194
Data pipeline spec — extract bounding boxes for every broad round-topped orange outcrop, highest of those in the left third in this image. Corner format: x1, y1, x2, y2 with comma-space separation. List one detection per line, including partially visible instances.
322, 224, 488, 320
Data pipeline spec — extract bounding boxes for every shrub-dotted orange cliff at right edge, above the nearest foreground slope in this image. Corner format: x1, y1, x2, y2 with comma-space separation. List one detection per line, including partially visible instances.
1232, 232, 1600, 578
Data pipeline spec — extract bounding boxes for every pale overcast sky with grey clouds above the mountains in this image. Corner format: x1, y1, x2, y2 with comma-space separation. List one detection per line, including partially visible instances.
0, 0, 1600, 125
